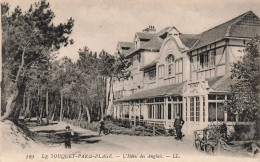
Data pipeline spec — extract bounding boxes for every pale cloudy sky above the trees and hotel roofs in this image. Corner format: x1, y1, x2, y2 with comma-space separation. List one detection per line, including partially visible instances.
5, 0, 260, 61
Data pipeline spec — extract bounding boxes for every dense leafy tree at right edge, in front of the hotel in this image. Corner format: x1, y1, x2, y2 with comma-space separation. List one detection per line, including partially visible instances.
227, 35, 260, 138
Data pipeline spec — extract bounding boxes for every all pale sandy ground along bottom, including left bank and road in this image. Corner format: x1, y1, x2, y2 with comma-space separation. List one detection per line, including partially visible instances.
0, 119, 260, 162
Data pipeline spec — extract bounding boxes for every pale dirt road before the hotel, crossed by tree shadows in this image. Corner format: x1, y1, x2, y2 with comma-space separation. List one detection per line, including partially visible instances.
24, 118, 204, 155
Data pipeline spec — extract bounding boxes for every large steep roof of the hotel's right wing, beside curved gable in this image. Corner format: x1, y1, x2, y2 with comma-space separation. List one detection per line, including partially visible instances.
190, 11, 260, 50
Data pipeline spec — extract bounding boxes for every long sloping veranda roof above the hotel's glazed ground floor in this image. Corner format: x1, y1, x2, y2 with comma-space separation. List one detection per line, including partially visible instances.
115, 82, 185, 102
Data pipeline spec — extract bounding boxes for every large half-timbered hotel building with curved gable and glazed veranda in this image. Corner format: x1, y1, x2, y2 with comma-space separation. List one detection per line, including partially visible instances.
107, 11, 260, 134
